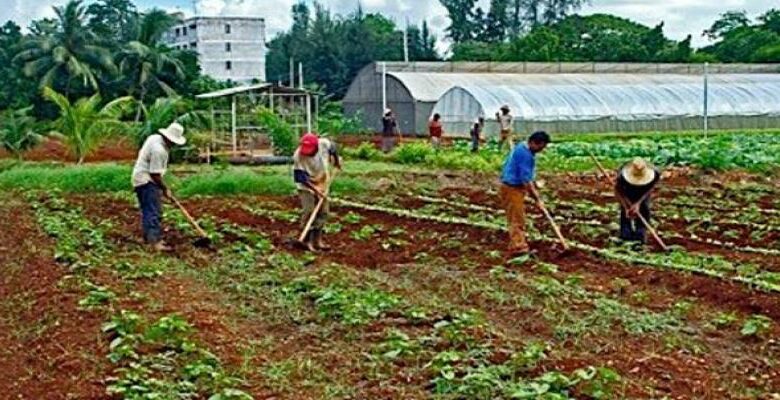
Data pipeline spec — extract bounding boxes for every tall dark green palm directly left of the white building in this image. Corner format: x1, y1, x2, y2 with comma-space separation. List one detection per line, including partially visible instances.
117, 9, 184, 121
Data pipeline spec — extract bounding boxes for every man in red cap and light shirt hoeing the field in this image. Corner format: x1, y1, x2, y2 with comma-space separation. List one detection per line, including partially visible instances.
293, 133, 341, 251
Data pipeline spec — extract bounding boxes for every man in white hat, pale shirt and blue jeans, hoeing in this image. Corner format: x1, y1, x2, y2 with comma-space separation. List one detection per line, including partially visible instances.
132, 122, 187, 251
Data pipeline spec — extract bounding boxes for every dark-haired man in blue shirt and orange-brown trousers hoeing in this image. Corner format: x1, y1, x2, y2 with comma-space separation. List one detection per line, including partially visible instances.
500, 131, 550, 257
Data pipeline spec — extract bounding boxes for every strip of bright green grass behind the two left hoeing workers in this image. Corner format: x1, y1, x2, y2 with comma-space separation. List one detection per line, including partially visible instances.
0, 163, 365, 197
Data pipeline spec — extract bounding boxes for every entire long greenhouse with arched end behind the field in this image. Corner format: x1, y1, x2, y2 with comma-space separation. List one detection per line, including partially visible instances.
344, 63, 780, 136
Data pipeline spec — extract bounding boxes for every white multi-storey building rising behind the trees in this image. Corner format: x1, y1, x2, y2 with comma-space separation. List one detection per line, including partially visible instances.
164, 17, 266, 82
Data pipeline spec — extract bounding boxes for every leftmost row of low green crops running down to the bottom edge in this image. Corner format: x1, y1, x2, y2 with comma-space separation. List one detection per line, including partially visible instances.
29, 194, 251, 400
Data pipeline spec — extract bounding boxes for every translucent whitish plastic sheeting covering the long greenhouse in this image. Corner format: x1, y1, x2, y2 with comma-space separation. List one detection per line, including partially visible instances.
400, 72, 780, 121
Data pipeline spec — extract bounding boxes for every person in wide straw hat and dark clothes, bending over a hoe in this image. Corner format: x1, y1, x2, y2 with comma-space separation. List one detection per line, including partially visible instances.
615, 157, 661, 243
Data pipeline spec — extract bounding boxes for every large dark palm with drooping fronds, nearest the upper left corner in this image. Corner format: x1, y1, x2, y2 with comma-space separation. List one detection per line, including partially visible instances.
15, 0, 116, 96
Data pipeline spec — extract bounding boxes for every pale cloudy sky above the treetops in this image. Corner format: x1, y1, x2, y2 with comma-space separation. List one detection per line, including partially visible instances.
0, 0, 780, 49
